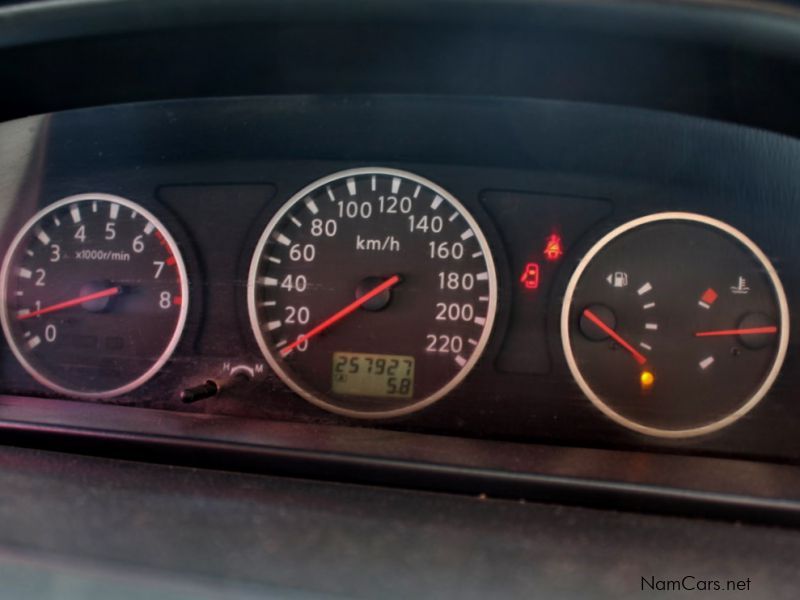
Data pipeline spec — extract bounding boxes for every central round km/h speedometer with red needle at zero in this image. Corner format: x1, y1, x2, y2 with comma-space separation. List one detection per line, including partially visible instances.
248, 168, 497, 418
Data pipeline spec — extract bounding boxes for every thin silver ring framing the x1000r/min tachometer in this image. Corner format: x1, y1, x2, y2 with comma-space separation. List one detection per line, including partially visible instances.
0, 192, 189, 400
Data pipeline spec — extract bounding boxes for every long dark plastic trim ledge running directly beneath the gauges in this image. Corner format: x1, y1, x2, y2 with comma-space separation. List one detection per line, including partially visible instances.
0, 396, 800, 526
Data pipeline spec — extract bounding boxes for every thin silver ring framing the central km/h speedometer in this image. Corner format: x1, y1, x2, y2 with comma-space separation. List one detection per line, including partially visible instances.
247, 167, 498, 420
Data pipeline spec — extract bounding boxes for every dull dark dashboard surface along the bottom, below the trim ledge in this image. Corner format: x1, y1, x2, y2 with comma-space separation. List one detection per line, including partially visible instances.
0, 449, 798, 599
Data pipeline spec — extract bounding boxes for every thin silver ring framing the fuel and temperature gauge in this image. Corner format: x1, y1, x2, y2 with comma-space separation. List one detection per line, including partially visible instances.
561, 212, 789, 439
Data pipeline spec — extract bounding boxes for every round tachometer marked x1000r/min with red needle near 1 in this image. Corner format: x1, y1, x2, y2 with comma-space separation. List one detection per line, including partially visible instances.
0, 194, 188, 398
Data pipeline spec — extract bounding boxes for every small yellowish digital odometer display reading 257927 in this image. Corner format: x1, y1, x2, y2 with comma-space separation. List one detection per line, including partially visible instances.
333, 352, 414, 398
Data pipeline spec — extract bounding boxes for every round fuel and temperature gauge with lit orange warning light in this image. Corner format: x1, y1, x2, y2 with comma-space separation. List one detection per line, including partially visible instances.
561, 213, 789, 437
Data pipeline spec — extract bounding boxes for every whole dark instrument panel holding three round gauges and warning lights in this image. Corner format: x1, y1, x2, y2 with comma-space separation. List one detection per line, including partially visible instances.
0, 96, 800, 461
